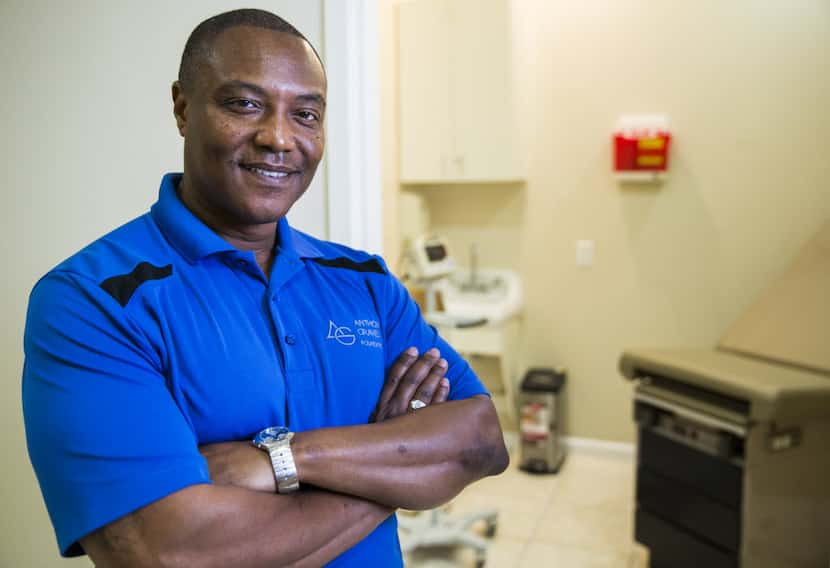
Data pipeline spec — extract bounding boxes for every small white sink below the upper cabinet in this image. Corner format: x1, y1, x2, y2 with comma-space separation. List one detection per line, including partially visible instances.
435, 269, 522, 324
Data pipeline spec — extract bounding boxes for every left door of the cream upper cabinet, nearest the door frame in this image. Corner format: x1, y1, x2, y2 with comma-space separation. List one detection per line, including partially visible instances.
399, 0, 452, 182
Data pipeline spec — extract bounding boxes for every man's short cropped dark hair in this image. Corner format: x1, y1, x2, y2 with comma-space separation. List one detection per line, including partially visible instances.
179, 8, 323, 91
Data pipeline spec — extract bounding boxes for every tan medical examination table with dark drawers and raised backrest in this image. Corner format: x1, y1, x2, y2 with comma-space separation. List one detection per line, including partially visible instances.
620, 221, 830, 568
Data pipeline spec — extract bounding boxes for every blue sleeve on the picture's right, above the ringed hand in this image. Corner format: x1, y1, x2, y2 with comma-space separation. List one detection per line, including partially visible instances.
378, 259, 489, 400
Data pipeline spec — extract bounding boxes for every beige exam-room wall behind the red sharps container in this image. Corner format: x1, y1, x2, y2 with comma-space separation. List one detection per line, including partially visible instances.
382, 0, 830, 441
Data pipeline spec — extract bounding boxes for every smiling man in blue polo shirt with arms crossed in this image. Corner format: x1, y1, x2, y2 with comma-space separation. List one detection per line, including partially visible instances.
23, 10, 507, 567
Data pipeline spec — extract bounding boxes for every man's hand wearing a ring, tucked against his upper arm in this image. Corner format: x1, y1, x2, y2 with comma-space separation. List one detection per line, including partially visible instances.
371, 347, 450, 422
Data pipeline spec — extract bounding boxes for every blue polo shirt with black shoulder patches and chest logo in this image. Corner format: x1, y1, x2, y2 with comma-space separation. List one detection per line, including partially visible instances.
23, 174, 485, 567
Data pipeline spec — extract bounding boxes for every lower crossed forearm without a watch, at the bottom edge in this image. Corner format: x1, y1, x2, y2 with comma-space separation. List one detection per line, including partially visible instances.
81, 485, 392, 568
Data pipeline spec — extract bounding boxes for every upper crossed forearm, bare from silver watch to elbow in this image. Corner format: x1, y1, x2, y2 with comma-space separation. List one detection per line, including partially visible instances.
292, 396, 508, 509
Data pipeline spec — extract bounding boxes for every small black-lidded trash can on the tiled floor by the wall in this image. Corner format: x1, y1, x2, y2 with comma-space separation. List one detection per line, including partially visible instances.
519, 368, 566, 473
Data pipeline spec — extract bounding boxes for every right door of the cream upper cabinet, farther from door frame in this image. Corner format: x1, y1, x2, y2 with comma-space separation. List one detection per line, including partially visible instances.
448, 0, 520, 181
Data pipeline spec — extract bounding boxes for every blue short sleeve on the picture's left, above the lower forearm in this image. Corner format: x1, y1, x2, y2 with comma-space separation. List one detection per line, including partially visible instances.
23, 272, 210, 556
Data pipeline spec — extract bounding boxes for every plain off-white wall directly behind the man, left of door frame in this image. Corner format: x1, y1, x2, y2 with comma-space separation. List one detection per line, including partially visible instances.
0, 0, 326, 568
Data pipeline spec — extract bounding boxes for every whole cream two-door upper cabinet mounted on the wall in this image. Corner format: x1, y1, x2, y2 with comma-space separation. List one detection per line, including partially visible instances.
399, 0, 524, 184
